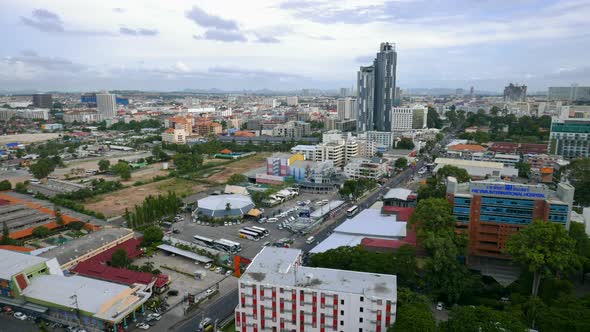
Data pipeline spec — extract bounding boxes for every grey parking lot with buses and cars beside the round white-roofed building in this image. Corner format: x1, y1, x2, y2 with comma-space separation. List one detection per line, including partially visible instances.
171, 189, 338, 259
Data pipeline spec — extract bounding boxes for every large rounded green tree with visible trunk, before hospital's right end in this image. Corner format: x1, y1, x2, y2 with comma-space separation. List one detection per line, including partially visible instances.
505, 220, 581, 296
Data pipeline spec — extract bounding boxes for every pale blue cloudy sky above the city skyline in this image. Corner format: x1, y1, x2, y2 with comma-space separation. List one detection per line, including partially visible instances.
0, 0, 590, 91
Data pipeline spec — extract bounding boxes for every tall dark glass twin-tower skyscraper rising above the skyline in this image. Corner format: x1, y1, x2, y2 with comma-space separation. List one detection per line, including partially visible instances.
357, 43, 397, 131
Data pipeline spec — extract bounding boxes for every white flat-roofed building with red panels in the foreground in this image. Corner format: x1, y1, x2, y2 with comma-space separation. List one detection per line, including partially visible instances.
235, 247, 397, 332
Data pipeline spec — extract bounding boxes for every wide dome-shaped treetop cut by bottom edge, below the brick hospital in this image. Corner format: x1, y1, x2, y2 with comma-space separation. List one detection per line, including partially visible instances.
439, 306, 527, 332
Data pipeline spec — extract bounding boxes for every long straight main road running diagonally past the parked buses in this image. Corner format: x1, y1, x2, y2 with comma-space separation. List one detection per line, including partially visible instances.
171, 129, 457, 332
